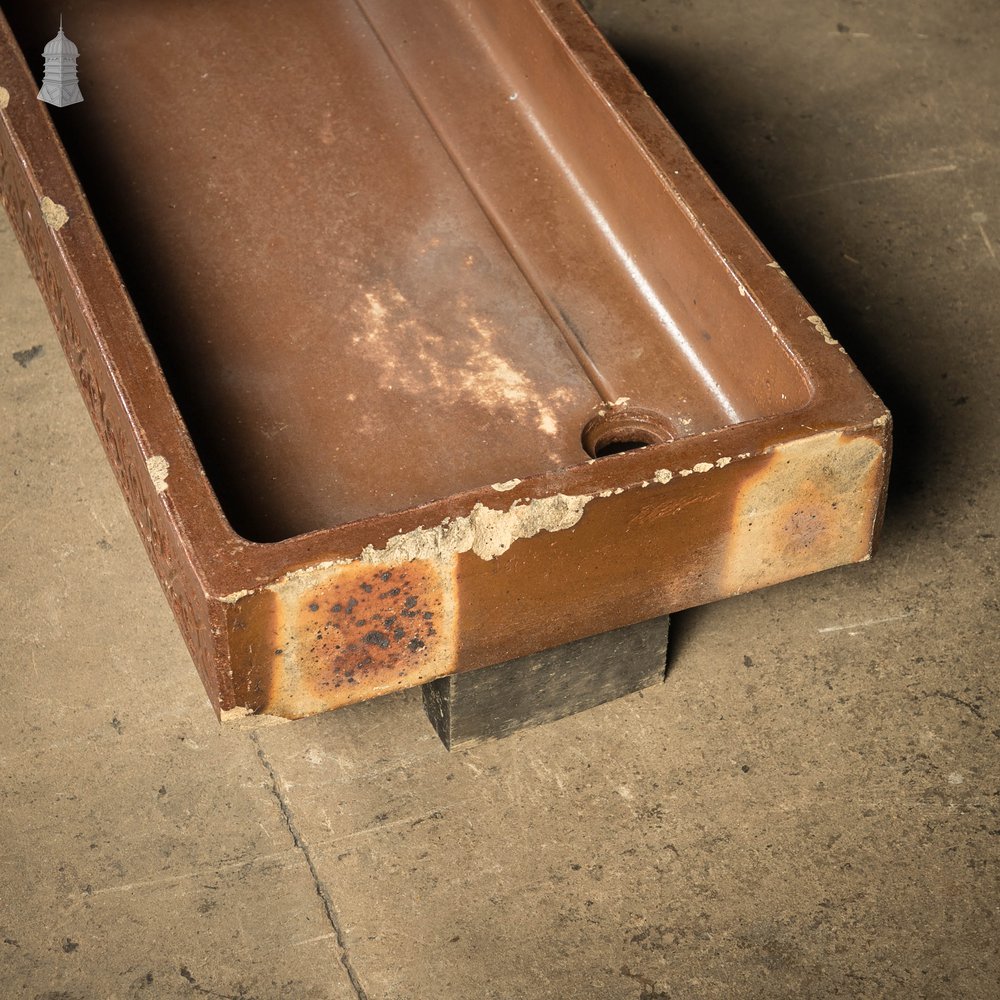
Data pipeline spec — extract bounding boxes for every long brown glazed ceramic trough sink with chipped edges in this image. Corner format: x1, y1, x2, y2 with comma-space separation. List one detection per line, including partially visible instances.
0, 0, 889, 717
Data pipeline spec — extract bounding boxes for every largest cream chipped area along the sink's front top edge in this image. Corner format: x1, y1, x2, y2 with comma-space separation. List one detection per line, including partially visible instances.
359, 493, 593, 565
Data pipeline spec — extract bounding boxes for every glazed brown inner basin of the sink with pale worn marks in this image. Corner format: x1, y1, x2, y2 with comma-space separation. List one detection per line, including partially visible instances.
10, 0, 808, 541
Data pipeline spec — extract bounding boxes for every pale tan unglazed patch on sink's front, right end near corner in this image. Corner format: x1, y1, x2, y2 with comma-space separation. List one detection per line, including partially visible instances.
721, 431, 886, 594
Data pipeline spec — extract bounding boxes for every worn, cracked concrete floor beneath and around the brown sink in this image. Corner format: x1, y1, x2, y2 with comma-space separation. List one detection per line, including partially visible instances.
0, 0, 1000, 1000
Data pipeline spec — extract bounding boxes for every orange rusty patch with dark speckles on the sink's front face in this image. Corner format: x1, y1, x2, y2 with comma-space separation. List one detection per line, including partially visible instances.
265, 561, 455, 717
